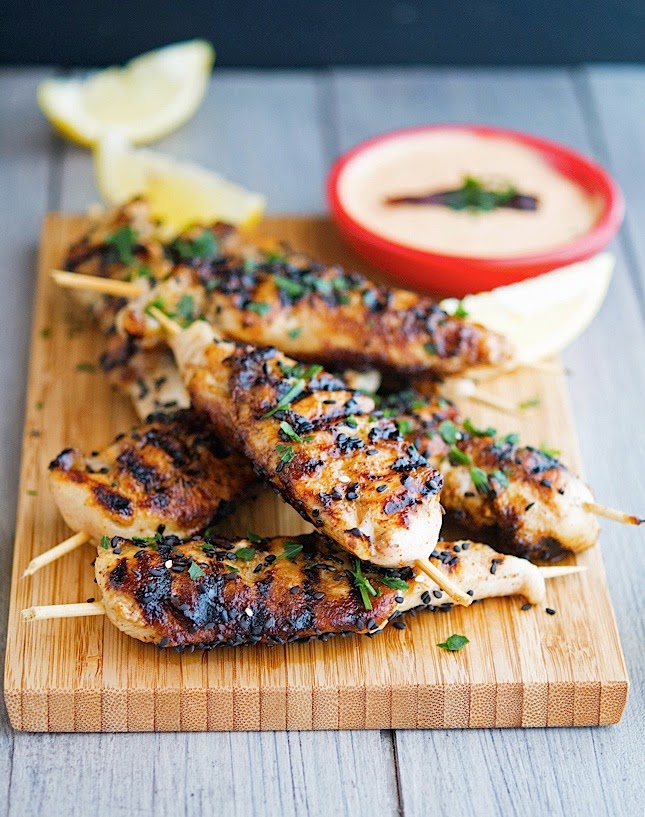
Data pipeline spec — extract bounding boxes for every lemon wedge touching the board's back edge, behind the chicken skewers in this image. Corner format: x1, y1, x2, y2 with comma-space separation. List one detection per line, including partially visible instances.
94, 132, 266, 230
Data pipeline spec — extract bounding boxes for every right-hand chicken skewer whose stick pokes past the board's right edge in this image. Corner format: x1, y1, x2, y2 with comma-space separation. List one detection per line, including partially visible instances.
376, 391, 641, 560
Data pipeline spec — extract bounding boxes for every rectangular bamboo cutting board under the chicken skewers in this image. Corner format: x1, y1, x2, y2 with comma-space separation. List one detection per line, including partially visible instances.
5, 215, 628, 732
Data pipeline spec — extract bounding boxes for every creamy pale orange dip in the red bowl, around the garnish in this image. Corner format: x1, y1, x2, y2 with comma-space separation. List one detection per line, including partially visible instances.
338, 130, 602, 258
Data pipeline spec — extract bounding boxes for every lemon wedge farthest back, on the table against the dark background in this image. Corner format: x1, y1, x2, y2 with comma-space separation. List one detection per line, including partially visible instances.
38, 40, 215, 146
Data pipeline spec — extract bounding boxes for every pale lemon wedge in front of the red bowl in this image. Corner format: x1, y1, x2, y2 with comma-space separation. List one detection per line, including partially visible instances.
441, 253, 615, 363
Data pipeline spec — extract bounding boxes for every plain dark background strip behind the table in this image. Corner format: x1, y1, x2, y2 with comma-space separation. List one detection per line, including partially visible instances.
0, 0, 645, 67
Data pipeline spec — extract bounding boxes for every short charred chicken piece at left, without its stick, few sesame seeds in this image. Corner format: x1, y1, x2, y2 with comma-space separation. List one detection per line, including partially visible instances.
49, 410, 257, 541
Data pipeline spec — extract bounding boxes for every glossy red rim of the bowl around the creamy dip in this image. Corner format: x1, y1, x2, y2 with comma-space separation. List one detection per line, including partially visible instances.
326, 122, 625, 277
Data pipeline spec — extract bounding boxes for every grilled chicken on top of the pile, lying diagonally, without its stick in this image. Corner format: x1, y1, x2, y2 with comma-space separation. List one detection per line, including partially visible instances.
171, 321, 442, 567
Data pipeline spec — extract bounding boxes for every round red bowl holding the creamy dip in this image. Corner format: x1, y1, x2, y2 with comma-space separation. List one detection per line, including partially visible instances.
327, 125, 624, 297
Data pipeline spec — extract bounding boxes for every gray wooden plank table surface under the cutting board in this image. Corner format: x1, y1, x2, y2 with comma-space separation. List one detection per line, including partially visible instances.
0, 67, 645, 817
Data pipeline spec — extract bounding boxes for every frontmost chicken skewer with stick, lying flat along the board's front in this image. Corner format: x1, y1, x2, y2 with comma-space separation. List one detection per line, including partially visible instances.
23, 533, 578, 649
